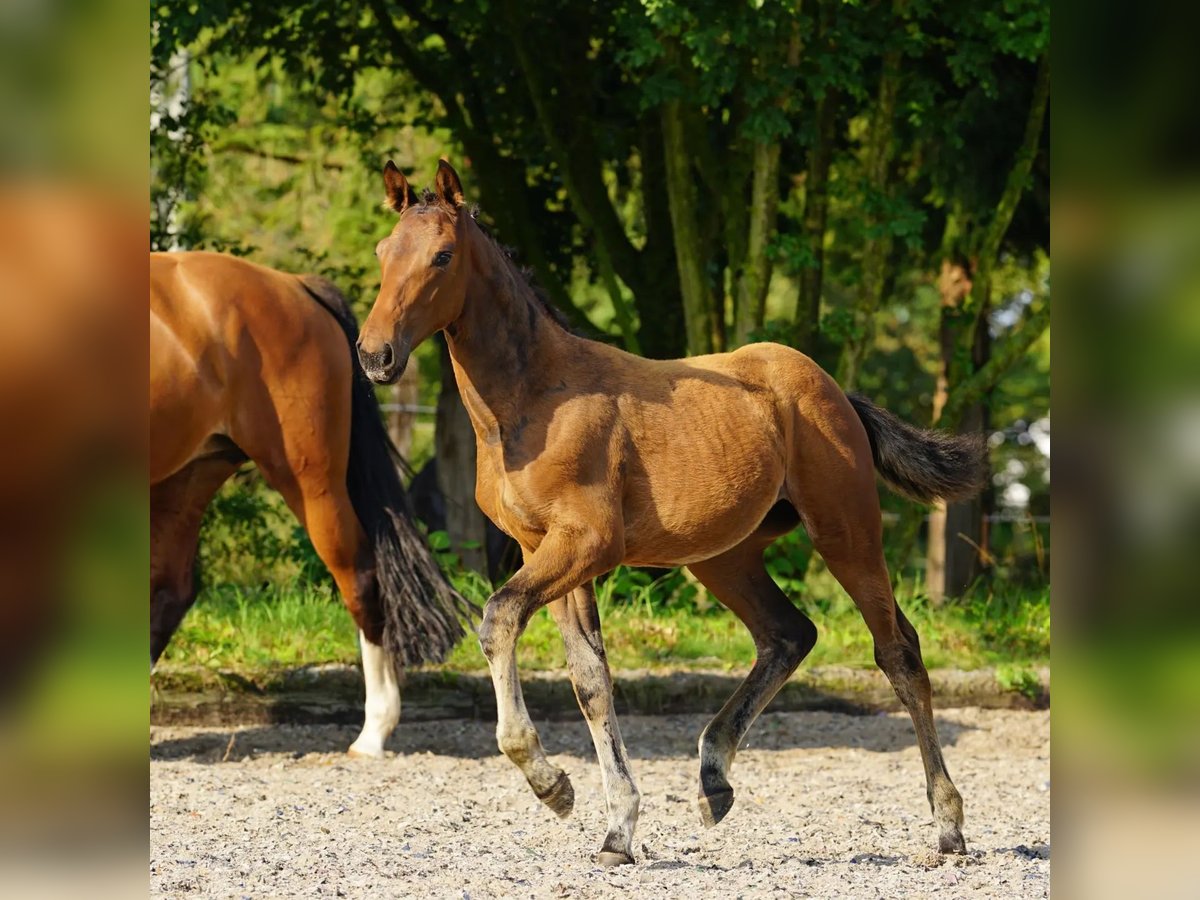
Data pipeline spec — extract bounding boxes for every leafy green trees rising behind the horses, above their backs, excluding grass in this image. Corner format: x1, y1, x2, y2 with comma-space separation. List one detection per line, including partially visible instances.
151, 0, 1049, 587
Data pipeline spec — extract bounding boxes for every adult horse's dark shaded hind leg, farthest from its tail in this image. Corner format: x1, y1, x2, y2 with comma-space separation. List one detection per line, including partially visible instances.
150, 458, 238, 665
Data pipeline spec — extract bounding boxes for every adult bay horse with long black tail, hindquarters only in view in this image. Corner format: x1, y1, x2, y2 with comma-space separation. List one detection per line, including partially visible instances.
150, 253, 464, 756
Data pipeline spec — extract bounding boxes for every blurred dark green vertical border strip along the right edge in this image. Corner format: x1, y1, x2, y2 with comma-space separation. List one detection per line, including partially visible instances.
1054, 4, 1200, 898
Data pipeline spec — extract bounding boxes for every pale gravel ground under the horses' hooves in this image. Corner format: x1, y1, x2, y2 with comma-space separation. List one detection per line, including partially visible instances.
150, 709, 1050, 900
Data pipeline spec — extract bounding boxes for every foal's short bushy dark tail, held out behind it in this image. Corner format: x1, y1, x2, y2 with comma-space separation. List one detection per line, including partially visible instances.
847, 394, 988, 503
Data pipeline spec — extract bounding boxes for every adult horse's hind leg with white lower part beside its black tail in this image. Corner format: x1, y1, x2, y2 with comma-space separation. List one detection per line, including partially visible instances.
260, 452, 400, 758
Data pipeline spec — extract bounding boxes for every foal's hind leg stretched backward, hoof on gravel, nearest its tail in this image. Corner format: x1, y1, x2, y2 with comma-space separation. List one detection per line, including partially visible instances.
798, 475, 966, 853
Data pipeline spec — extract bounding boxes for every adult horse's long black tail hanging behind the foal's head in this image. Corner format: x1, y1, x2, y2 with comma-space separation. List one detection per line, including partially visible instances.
300, 275, 479, 666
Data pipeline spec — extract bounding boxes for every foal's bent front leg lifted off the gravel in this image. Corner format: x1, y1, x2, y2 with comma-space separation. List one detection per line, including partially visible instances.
479, 529, 612, 817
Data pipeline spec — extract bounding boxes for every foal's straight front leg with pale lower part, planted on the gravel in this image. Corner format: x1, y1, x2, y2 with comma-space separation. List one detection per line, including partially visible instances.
550, 584, 641, 865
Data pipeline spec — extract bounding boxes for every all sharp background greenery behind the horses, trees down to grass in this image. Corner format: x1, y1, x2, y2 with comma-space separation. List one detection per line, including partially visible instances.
151, 0, 1050, 665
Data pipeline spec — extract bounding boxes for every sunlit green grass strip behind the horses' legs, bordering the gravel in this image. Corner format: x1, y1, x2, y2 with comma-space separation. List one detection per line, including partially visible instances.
164, 572, 1050, 677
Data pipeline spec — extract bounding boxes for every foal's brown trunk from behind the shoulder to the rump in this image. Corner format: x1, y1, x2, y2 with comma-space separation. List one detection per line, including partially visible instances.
549, 343, 859, 565
